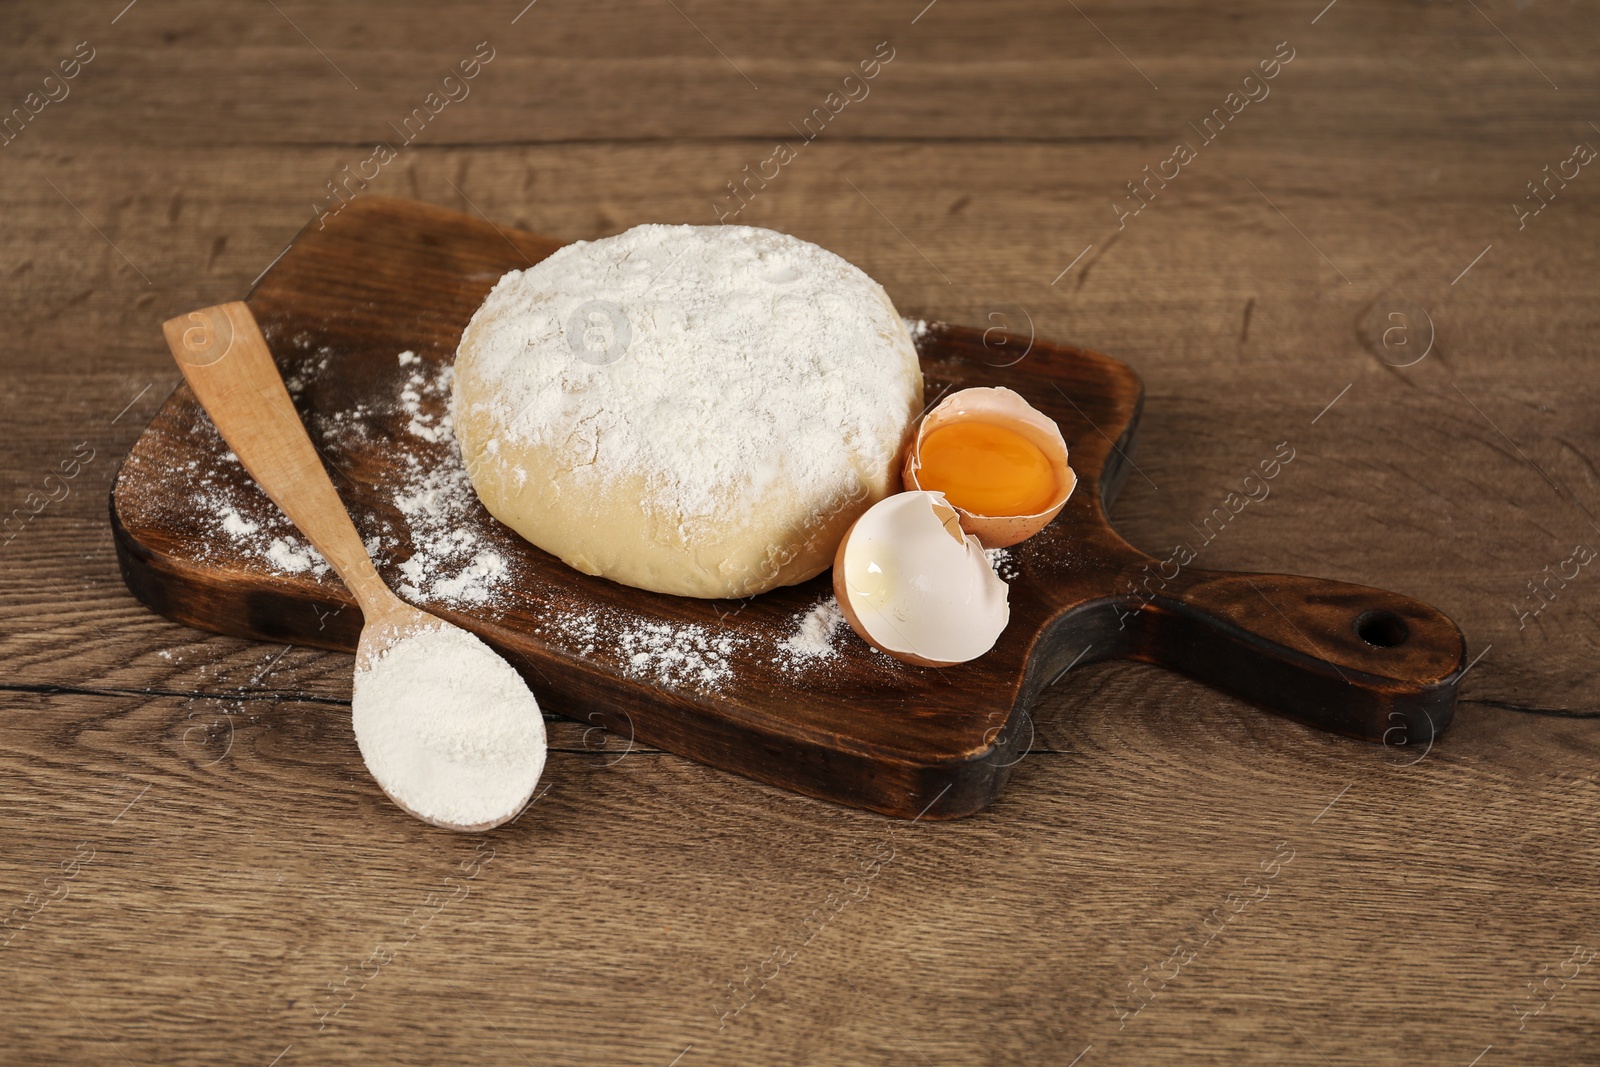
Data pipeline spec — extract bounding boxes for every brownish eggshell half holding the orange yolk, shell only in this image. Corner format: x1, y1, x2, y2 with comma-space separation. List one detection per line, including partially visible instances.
901, 387, 1078, 549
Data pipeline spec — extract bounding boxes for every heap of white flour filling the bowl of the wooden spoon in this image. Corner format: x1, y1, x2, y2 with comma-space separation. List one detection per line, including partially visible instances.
350, 624, 546, 827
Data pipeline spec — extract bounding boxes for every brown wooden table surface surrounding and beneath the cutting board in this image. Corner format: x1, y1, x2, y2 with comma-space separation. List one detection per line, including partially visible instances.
0, 0, 1600, 1067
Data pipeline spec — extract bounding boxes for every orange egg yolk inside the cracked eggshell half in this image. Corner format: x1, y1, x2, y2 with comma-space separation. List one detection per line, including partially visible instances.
917, 421, 1058, 515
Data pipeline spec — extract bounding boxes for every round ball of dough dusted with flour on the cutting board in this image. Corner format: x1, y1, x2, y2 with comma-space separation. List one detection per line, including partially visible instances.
453, 226, 922, 597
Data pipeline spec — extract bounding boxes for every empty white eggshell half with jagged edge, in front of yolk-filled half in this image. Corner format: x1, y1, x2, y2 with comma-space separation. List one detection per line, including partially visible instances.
834, 493, 1011, 667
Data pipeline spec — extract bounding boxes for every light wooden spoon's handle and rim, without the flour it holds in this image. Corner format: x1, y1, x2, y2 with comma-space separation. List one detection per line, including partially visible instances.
162, 301, 544, 832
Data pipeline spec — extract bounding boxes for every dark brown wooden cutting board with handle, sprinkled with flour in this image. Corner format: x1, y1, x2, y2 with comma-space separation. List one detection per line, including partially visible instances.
112, 197, 1466, 819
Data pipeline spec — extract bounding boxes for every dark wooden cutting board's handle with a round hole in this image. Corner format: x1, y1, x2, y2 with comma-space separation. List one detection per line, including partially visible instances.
1114, 560, 1466, 747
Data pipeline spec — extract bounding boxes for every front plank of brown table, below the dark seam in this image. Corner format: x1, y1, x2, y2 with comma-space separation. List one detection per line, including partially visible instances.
0, 684, 1600, 1064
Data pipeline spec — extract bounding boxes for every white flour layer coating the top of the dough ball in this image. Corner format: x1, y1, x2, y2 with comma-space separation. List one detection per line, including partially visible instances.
456, 226, 915, 539
